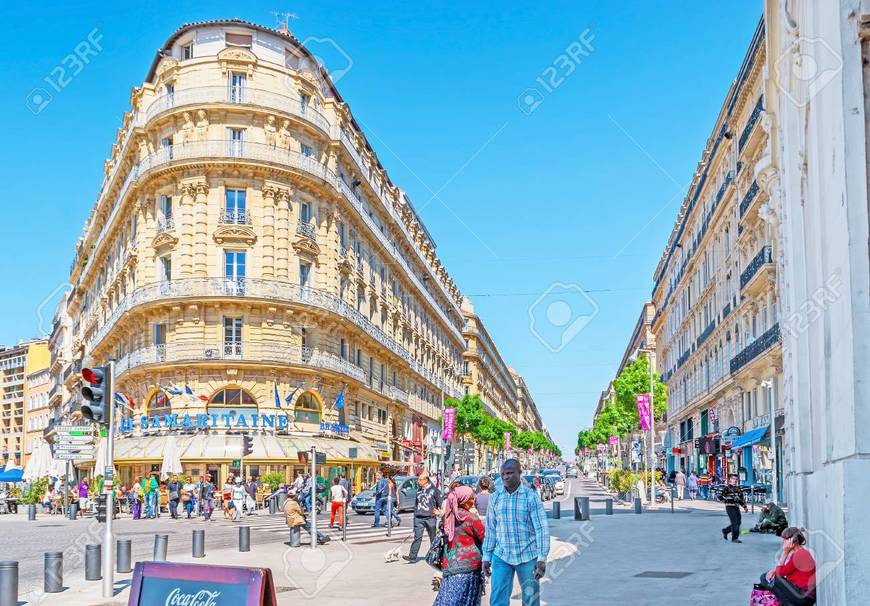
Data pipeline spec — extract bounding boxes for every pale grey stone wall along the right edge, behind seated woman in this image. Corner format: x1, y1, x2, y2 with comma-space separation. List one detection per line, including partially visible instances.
762, 0, 870, 606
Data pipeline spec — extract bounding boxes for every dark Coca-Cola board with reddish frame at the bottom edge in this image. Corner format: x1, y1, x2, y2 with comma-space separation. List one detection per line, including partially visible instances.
127, 562, 277, 606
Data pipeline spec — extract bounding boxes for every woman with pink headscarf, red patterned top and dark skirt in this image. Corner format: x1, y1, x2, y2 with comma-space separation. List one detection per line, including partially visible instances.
434, 486, 485, 606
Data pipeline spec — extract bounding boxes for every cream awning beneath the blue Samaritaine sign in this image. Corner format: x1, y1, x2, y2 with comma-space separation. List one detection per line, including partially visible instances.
115, 433, 378, 463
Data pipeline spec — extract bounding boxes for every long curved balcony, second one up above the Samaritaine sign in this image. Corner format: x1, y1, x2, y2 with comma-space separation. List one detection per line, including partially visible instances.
87, 278, 458, 402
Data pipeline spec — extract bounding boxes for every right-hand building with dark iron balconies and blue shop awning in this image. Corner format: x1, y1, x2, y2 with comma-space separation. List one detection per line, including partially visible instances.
652, 22, 783, 498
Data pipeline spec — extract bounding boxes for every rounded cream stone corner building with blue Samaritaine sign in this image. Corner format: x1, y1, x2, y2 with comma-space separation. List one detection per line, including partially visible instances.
53, 20, 544, 492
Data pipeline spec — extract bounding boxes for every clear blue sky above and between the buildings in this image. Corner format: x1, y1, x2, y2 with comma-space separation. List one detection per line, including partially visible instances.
0, 0, 761, 452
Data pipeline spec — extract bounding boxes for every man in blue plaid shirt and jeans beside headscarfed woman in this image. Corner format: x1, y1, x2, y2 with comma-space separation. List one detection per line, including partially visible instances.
483, 459, 550, 606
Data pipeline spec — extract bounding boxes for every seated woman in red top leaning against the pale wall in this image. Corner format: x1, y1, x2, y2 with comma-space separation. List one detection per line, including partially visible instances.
760, 527, 816, 606
